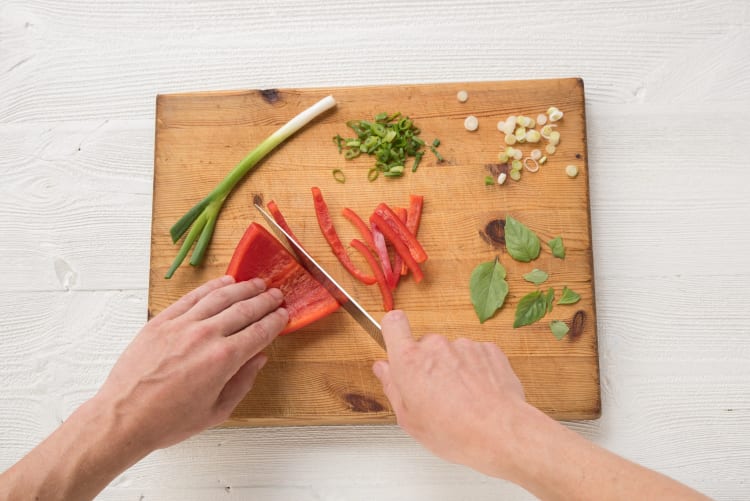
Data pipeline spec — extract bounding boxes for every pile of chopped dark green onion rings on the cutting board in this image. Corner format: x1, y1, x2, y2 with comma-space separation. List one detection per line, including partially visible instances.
333, 112, 444, 181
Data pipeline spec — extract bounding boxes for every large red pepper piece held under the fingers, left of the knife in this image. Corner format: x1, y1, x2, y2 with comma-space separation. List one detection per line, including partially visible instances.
227, 223, 339, 334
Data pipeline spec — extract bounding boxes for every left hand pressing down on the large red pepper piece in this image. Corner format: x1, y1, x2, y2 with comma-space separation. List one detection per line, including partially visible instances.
94, 276, 289, 453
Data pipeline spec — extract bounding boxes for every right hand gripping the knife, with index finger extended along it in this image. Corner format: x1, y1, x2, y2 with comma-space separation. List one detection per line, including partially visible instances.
373, 311, 537, 480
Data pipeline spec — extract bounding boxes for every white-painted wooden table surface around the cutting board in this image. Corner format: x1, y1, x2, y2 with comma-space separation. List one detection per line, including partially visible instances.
0, 0, 750, 501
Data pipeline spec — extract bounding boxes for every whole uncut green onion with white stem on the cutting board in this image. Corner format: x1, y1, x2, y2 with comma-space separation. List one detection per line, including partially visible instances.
165, 96, 340, 278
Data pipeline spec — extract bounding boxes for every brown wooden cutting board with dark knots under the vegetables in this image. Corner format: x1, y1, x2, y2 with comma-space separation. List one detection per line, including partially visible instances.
149, 79, 600, 426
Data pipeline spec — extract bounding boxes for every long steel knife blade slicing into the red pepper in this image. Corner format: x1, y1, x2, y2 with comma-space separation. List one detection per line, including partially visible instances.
254, 204, 385, 350
